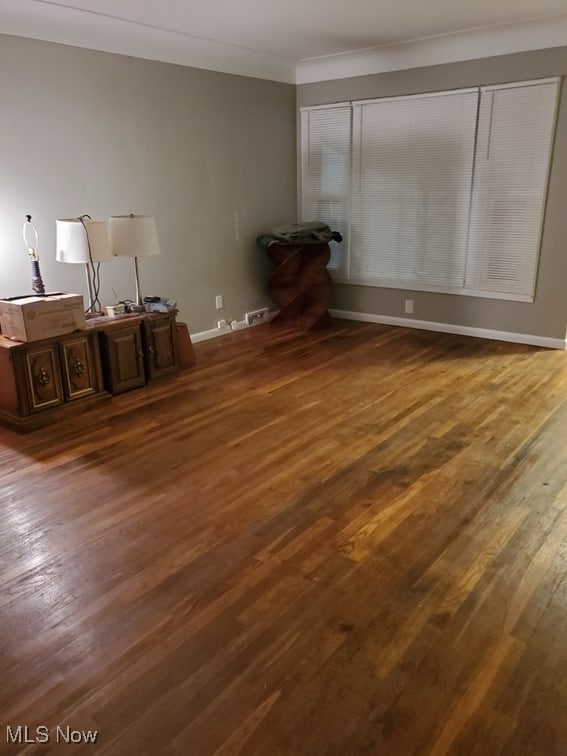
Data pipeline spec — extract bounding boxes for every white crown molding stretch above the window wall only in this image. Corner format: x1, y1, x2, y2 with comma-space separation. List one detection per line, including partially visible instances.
296, 16, 567, 84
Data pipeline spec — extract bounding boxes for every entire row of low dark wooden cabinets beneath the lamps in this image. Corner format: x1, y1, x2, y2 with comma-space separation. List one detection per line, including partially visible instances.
0, 312, 180, 431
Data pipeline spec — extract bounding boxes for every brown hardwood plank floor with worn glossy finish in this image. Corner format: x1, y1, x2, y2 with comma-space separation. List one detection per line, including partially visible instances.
0, 321, 567, 756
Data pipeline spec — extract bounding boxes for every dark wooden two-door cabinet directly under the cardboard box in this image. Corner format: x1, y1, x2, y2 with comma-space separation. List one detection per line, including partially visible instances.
0, 331, 110, 431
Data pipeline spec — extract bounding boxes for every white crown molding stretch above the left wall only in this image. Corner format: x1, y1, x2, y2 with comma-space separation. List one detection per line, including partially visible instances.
0, 0, 296, 84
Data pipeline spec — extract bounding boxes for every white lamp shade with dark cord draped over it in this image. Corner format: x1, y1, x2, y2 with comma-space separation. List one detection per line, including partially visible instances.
55, 218, 112, 265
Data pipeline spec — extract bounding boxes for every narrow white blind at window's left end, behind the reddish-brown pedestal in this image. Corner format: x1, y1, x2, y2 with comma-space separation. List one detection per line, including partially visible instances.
300, 105, 352, 274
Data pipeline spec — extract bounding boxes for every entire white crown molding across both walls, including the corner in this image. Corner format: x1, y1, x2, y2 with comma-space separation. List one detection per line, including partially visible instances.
0, 0, 567, 84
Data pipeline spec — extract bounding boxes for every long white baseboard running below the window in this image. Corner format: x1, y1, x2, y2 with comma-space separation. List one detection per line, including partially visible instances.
329, 310, 567, 349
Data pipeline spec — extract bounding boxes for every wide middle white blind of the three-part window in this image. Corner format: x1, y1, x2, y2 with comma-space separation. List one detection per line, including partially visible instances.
350, 90, 478, 286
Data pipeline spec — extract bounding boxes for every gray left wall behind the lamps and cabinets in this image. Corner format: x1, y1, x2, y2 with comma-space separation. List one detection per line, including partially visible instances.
0, 35, 296, 333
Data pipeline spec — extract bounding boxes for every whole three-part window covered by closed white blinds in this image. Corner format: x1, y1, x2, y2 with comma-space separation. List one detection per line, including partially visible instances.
301, 79, 558, 300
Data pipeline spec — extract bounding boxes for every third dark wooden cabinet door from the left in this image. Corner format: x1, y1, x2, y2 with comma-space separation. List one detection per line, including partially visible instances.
101, 325, 145, 394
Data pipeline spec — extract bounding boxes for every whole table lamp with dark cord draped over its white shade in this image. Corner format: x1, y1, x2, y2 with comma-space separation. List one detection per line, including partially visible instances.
55, 215, 112, 313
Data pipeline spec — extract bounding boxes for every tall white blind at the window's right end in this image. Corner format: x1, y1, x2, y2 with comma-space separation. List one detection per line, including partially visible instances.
467, 81, 558, 299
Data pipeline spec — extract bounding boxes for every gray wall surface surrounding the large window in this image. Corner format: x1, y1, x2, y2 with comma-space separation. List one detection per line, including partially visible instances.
297, 48, 567, 339
